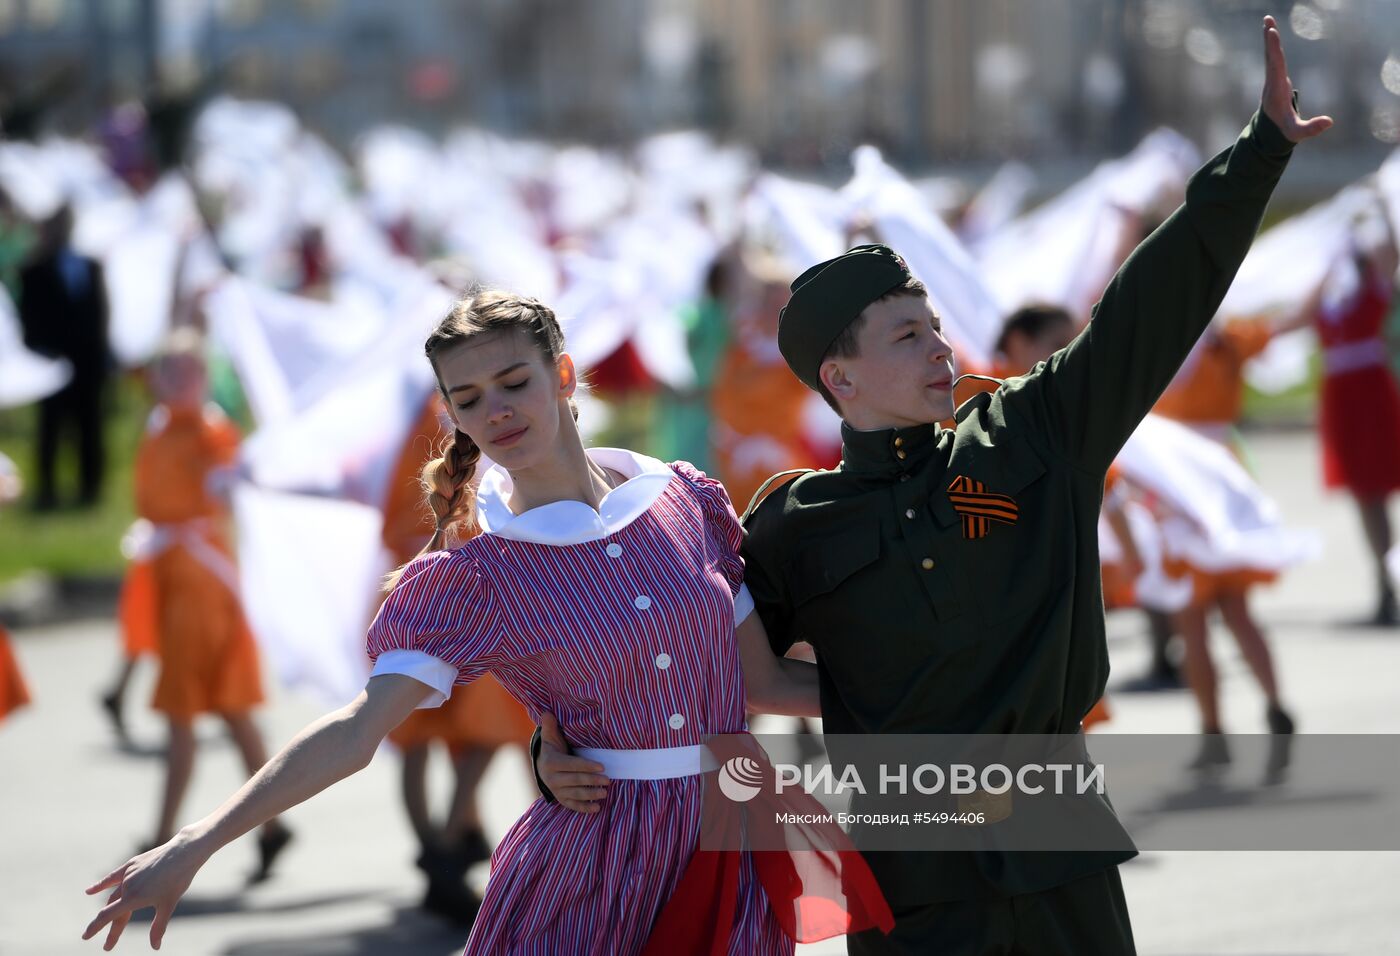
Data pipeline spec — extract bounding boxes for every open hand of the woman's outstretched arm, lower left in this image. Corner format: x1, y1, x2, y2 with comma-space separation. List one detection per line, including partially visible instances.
83, 830, 209, 949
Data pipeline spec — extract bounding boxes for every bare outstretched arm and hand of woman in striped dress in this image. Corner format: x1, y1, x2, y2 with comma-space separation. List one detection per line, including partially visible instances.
83, 673, 428, 949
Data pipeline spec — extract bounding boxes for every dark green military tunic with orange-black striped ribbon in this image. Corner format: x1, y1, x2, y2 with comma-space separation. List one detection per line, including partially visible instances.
743, 106, 1292, 907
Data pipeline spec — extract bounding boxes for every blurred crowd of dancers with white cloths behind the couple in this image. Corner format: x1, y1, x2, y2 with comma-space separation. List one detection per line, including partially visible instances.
0, 93, 1400, 914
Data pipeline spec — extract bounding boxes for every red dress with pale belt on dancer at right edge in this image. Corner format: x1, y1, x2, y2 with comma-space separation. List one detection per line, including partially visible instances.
1316, 267, 1400, 497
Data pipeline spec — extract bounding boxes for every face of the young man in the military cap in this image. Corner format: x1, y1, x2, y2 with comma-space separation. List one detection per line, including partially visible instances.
822, 295, 953, 428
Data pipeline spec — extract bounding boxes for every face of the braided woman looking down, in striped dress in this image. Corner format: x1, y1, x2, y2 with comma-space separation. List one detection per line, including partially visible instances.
437, 332, 577, 470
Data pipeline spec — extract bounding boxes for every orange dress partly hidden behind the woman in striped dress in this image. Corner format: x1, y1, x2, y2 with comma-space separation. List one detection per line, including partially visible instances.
384, 393, 535, 750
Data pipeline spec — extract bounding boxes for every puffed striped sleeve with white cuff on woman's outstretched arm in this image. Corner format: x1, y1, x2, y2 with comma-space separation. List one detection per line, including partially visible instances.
365, 550, 501, 707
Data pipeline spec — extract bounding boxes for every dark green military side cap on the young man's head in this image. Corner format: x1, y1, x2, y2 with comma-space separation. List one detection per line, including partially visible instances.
778, 242, 910, 389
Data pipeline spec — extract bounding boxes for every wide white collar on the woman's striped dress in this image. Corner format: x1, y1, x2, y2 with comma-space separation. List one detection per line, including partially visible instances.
476, 448, 675, 546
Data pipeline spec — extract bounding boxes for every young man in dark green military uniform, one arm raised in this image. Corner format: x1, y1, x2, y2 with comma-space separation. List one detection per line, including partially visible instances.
539, 18, 1331, 956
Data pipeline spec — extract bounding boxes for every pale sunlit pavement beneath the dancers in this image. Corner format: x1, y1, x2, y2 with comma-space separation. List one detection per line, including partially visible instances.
0, 434, 1400, 956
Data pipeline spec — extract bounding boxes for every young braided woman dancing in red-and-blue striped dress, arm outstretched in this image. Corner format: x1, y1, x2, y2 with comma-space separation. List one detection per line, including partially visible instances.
84, 293, 888, 955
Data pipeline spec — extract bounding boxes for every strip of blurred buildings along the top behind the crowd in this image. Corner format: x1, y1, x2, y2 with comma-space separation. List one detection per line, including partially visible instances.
0, 0, 1400, 167
